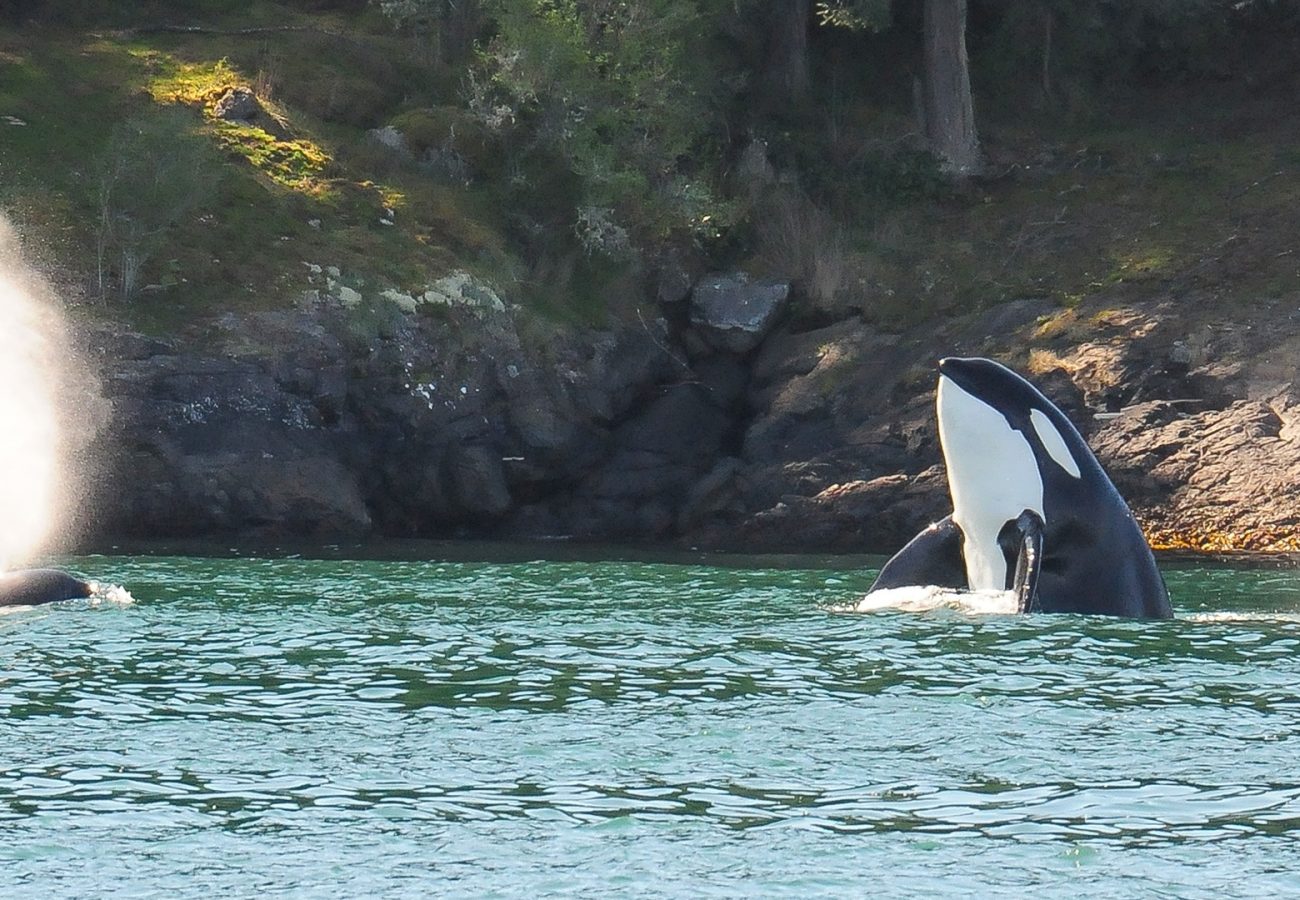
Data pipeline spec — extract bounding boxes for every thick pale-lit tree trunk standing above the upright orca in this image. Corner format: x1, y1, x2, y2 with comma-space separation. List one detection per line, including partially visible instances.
926, 0, 983, 176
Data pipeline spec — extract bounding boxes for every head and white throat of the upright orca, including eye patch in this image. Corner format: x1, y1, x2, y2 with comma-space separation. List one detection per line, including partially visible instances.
936, 358, 1092, 590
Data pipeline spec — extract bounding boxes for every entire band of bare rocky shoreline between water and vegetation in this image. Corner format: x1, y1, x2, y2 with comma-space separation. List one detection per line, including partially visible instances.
73, 265, 1300, 553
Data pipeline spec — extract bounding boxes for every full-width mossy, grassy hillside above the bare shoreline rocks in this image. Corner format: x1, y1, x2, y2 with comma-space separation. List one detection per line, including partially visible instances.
0, 0, 1297, 334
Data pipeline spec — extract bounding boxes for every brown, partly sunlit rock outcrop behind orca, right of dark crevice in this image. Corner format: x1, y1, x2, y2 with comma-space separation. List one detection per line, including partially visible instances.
670, 284, 1300, 551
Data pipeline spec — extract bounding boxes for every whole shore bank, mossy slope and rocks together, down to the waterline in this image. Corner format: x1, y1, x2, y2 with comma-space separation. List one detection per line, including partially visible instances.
0, 0, 1300, 550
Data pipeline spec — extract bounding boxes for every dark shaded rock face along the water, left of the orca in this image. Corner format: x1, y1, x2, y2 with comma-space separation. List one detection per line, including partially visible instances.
91, 299, 738, 538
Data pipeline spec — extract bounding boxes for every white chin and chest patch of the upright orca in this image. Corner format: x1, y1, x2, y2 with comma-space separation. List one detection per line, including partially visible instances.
936, 376, 1047, 590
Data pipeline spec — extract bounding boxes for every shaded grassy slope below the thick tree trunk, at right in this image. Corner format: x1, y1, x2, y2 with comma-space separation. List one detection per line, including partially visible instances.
861, 94, 1300, 326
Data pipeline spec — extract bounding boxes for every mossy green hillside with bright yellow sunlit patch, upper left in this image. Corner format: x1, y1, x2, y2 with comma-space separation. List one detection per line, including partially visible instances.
0, 4, 519, 333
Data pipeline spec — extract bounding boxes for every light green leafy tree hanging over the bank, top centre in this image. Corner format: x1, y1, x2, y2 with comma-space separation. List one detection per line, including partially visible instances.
481, 0, 733, 244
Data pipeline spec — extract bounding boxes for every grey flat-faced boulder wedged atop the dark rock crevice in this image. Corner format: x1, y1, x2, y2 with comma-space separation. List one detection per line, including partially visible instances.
690, 272, 790, 354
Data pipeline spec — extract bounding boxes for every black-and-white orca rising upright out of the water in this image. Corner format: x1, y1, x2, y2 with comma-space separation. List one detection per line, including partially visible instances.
868, 358, 1173, 619
